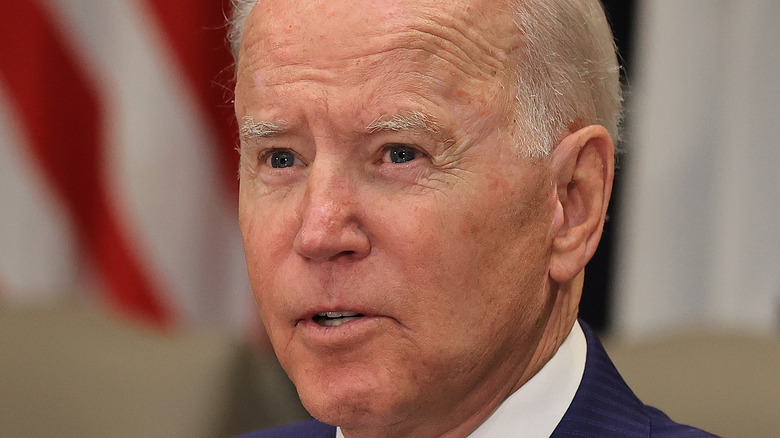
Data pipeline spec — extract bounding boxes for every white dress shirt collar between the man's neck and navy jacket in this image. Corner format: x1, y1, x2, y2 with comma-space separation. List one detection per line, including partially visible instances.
336, 322, 588, 438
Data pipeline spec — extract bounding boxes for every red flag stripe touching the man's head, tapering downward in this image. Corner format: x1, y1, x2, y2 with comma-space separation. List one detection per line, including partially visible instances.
146, 0, 238, 192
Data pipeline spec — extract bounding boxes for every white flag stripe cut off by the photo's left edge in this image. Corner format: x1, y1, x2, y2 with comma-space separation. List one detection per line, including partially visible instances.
0, 82, 78, 304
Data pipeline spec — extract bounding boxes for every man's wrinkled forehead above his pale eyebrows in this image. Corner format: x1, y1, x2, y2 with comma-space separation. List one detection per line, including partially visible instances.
236, 0, 520, 139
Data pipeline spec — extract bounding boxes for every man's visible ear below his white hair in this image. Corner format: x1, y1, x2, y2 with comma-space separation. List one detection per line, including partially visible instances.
550, 125, 615, 283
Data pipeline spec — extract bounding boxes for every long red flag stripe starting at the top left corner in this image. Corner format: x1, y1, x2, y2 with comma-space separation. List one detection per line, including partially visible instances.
0, 0, 172, 325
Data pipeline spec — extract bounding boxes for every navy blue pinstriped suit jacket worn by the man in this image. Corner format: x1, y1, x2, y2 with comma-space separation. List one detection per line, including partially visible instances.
238, 321, 715, 438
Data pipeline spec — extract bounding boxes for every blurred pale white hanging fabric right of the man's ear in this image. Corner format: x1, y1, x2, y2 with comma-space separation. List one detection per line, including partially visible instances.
612, 0, 780, 338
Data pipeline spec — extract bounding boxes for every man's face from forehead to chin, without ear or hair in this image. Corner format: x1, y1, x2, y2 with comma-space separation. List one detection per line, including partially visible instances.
236, 0, 555, 428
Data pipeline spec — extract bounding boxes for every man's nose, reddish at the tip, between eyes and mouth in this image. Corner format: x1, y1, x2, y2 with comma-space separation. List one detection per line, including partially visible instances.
293, 162, 371, 261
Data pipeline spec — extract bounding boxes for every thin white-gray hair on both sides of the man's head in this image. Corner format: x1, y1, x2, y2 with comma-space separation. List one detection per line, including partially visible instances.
228, 0, 623, 158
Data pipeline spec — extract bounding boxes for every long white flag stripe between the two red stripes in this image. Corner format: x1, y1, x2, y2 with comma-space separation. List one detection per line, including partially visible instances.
39, 0, 254, 326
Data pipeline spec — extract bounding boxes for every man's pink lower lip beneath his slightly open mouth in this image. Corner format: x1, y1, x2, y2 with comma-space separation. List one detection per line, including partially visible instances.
295, 315, 388, 348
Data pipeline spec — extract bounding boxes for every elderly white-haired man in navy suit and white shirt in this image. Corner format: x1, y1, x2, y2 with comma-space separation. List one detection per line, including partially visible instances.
233, 0, 720, 438
